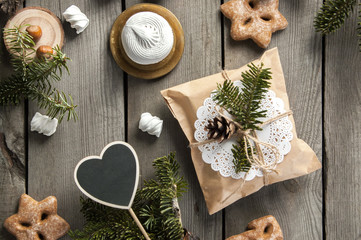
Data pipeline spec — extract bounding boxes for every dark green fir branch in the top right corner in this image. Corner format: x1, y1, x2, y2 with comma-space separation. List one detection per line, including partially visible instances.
314, 0, 356, 34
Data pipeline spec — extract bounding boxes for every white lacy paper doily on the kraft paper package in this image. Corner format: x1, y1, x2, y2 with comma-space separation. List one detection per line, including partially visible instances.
194, 81, 293, 181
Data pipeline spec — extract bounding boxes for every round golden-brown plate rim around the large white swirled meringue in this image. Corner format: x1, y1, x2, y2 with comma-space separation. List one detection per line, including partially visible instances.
110, 3, 184, 79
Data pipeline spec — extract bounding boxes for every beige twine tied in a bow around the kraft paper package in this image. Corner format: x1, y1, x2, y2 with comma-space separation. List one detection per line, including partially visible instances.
190, 70, 293, 204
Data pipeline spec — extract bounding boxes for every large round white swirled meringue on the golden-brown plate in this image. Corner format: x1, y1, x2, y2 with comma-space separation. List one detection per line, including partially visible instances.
121, 12, 174, 65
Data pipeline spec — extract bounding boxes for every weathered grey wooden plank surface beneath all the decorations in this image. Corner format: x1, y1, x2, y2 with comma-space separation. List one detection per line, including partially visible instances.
0, 0, 361, 240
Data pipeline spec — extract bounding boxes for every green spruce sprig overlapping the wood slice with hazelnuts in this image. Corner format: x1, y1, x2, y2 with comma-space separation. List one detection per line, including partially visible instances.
0, 25, 77, 122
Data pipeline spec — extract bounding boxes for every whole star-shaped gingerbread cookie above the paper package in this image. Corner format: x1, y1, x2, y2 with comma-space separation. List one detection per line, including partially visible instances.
221, 0, 288, 48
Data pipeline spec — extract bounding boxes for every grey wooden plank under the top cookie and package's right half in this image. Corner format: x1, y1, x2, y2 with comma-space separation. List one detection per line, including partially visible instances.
224, 0, 322, 240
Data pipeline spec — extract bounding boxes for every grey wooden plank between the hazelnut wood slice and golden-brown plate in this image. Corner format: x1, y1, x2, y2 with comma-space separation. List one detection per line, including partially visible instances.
26, 0, 124, 235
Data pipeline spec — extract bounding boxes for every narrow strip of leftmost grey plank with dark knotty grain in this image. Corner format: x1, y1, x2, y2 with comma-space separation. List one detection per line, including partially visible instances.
0, 12, 26, 239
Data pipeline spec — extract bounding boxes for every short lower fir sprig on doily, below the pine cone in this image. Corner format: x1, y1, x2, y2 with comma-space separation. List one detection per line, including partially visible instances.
232, 138, 252, 173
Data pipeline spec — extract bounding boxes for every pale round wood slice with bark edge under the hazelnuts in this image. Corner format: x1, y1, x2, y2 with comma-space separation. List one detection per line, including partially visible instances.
4, 7, 64, 57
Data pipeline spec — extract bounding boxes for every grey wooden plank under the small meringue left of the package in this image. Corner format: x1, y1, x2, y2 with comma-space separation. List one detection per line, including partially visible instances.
126, 0, 222, 239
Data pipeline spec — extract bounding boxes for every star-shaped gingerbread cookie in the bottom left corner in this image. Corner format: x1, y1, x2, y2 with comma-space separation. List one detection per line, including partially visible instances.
4, 194, 70, 240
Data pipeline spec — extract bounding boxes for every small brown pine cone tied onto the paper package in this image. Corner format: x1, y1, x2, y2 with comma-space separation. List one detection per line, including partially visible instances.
206, 116, 237, 143
